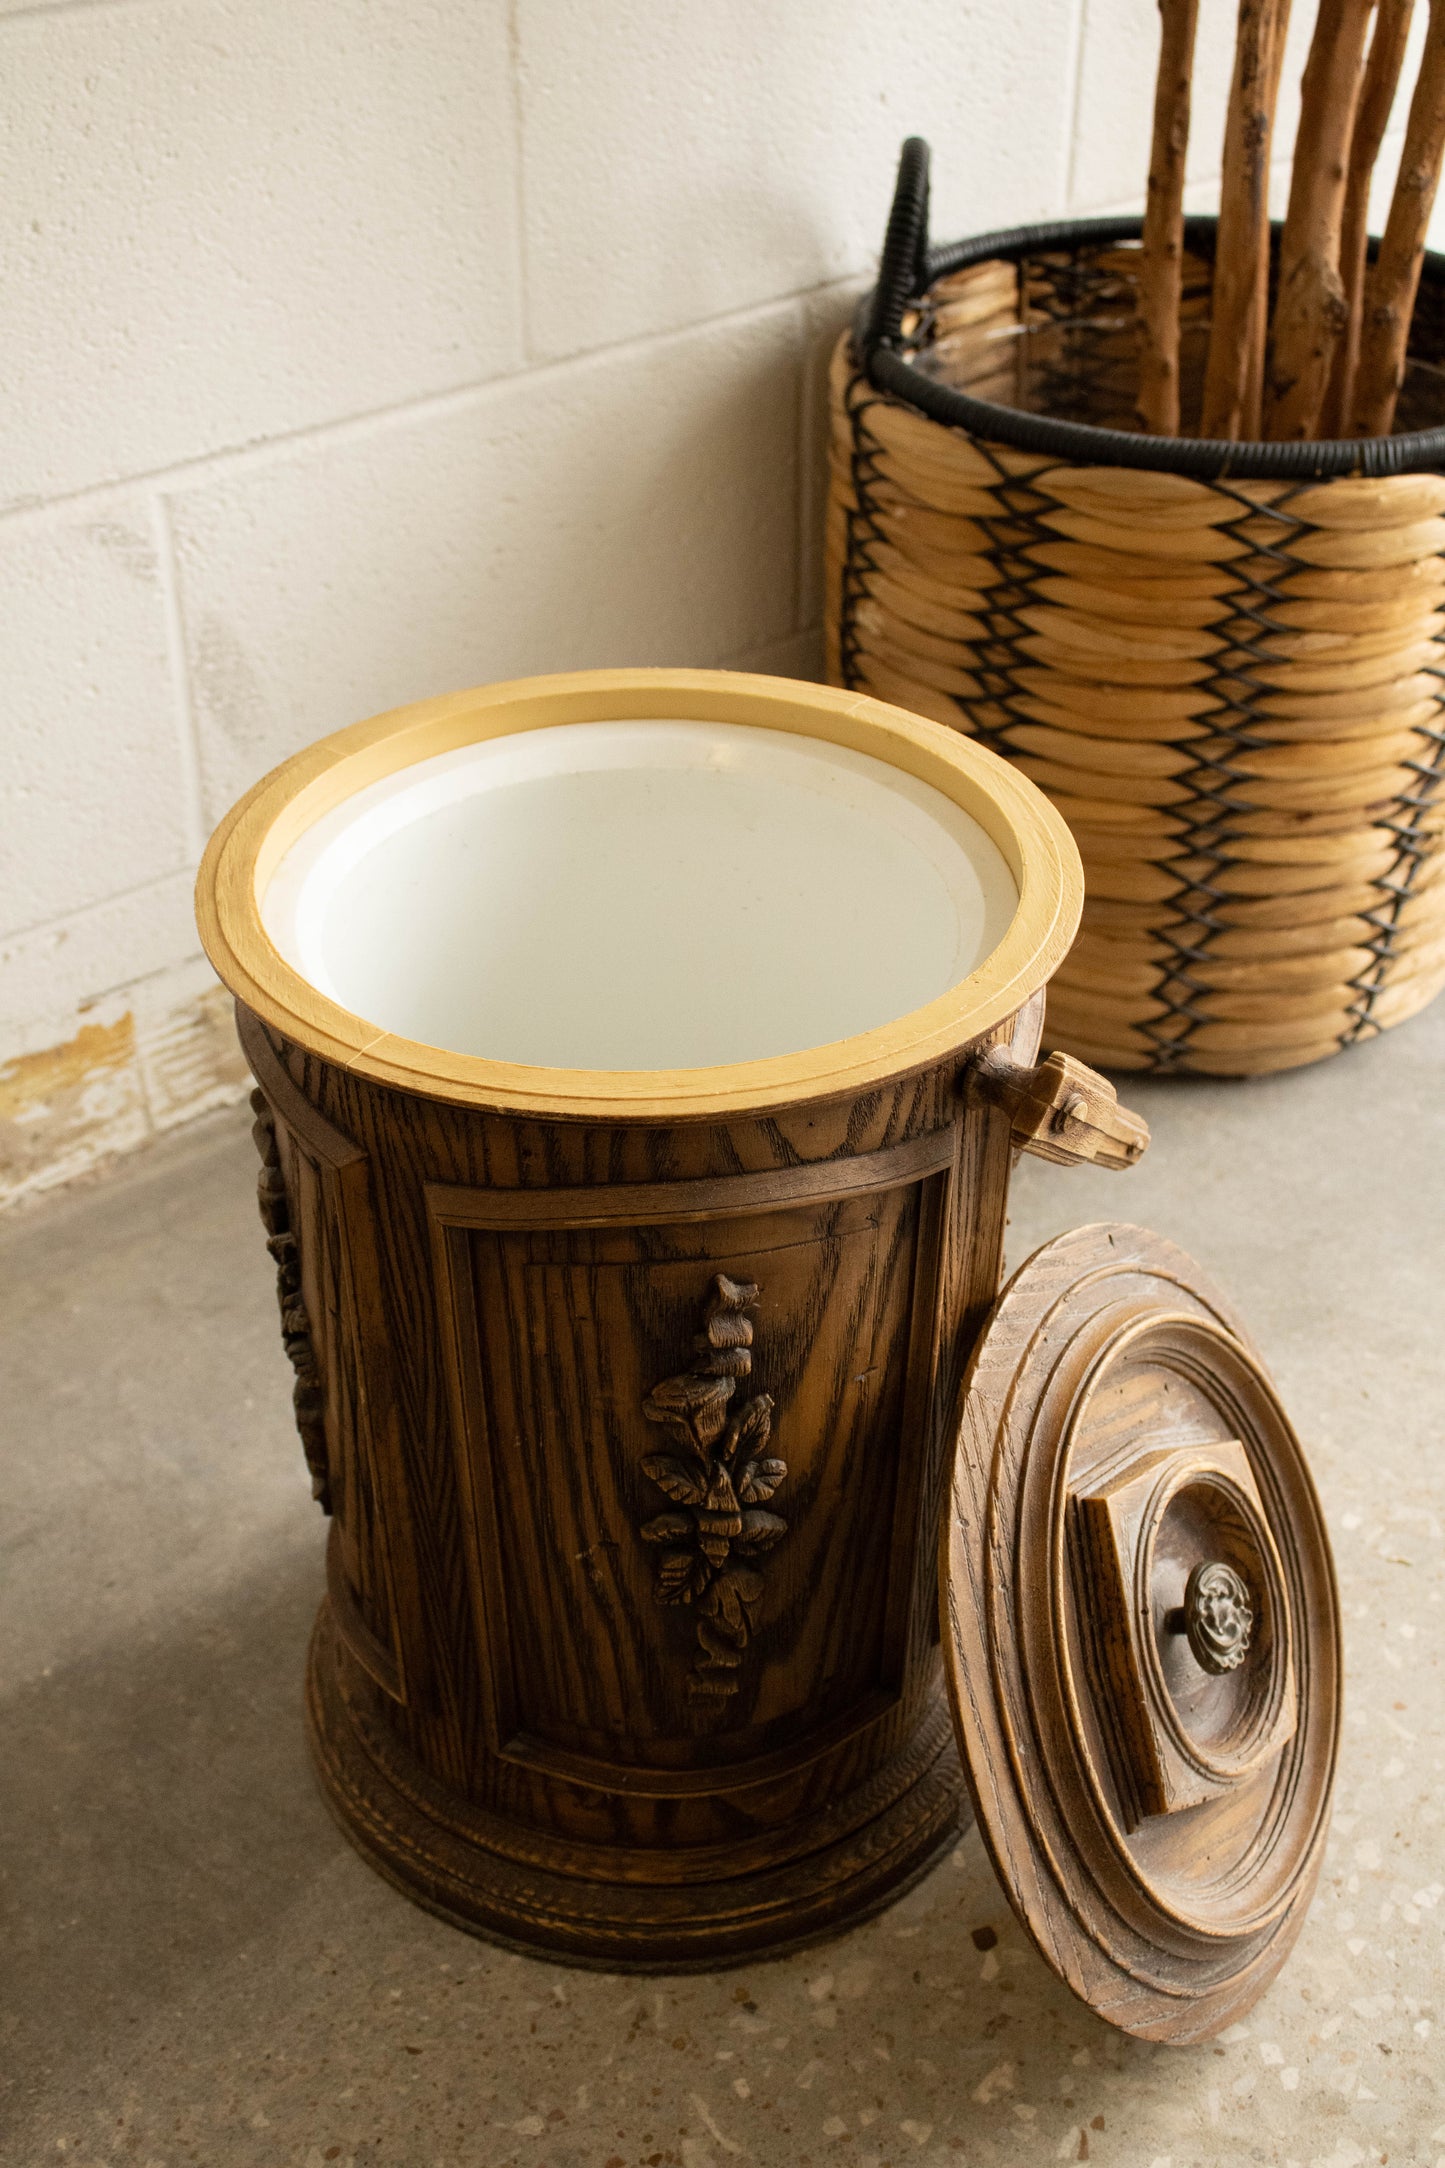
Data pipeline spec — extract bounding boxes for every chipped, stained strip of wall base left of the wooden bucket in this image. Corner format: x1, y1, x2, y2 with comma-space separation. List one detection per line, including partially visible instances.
0, 967, 249, 1210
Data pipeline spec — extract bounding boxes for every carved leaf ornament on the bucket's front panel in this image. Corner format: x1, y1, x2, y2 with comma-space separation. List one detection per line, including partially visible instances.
639, 1273, 789, 1700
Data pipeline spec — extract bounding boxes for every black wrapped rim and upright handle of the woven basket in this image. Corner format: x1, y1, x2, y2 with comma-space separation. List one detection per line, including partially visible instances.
854, 137, 1445, 481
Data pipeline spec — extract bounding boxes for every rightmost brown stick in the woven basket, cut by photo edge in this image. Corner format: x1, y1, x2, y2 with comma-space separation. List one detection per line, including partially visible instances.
1354, 0, 1445, 436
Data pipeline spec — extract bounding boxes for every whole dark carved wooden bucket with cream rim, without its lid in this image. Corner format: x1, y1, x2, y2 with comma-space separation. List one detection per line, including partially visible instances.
197, 670, 1135, 1969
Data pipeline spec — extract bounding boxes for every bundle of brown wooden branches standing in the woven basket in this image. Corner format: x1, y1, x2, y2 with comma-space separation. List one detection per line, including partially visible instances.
1140, 0, 1445, 440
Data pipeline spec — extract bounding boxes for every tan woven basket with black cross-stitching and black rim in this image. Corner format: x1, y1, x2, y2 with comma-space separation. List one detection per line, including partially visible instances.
828, 141, 1445, 1075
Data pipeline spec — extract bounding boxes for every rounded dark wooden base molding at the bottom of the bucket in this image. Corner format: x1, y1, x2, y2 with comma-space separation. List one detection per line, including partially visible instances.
305, 1602, 971, 1973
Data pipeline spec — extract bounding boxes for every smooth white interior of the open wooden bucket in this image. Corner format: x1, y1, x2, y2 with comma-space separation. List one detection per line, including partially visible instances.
262, 720, 1018, 1071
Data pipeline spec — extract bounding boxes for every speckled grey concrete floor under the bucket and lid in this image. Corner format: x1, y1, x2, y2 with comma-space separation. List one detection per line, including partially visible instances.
0, 1004, 1445, 2168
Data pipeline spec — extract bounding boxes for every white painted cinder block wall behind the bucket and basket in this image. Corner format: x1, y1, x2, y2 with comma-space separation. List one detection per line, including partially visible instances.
0, 0, 1421, 1197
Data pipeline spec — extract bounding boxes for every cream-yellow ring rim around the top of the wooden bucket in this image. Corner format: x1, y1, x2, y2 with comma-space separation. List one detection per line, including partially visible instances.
195, 670, 1083, 1121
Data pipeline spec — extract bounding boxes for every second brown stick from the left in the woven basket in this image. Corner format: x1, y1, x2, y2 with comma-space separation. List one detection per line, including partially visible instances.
1200, 0, 1289, 440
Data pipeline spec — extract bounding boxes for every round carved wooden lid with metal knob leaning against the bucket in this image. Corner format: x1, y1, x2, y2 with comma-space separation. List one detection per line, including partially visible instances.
940, 1225, 1341, 2042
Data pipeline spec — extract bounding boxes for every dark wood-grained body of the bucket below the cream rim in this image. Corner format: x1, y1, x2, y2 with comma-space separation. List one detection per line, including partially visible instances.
228, 999, 1061, 1969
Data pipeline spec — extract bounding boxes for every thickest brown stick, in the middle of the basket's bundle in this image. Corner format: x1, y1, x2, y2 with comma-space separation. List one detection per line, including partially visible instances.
1265, 0, 1374, 438
